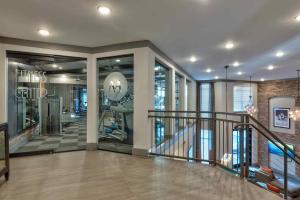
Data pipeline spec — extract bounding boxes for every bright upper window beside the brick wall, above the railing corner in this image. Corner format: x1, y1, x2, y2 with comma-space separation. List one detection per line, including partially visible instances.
233, 86, 250, 112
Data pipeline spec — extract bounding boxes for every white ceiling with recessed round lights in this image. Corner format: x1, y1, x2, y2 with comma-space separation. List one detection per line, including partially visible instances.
0, 0, 300, 80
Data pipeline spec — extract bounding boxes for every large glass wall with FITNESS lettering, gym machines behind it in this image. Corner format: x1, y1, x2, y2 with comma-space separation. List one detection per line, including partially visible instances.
7, 52, 87, 154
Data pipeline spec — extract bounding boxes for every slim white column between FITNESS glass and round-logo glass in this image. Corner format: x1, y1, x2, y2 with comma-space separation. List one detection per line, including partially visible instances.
86, 55, 99, 150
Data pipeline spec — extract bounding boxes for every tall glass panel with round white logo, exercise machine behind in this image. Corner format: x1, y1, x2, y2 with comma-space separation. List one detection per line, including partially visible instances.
97, 55, 134, 154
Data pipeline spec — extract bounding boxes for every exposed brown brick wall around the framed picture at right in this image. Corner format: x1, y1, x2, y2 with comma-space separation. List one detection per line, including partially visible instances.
257, 80, 300, 176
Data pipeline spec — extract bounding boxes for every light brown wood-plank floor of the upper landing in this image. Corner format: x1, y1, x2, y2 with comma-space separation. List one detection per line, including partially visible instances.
0, 151, 281, 200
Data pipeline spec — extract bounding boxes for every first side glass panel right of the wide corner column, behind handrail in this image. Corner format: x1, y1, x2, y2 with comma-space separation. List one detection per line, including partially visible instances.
154, 62, 171, 145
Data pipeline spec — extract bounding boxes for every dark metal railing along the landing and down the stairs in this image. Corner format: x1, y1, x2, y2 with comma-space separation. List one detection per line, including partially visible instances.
148, 110, 300, 198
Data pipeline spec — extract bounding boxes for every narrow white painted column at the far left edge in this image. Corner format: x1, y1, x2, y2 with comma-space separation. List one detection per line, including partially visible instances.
0, 44, 7, 124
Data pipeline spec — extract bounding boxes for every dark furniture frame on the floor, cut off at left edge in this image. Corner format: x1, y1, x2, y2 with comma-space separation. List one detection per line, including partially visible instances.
0, 124, 9, 180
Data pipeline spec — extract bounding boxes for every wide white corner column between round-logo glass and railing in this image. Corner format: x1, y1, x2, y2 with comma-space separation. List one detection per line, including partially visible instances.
132, 48, 155, 155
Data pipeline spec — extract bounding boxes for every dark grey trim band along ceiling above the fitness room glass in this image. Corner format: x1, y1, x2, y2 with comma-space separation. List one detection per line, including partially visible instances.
0, 36, 195, 80
